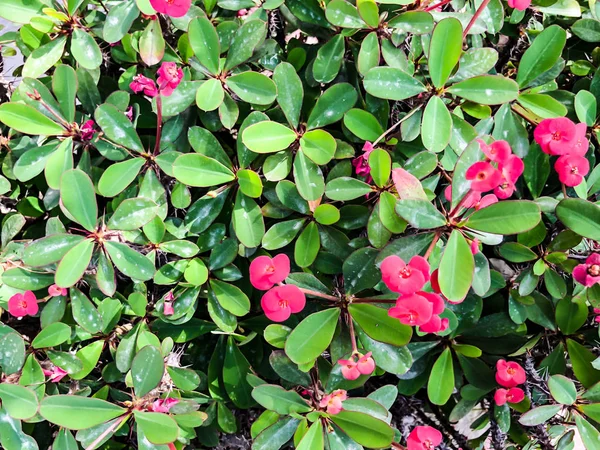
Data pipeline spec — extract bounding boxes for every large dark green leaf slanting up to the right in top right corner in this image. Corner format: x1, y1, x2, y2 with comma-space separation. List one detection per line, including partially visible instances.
517, 25, 567, 88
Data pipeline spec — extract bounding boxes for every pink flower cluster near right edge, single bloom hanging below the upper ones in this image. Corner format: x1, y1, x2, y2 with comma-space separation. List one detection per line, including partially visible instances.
533, 117, 590, 187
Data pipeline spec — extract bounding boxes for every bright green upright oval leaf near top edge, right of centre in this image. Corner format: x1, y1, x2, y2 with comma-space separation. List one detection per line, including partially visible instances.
427, 17, 463, 88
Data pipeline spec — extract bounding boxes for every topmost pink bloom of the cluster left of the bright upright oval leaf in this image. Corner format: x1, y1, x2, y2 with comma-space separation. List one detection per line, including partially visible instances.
381, 255, 430, 294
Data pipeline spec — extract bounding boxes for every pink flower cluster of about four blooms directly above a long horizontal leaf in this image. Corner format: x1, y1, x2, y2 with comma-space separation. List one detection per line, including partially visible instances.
465, 139, 525, 199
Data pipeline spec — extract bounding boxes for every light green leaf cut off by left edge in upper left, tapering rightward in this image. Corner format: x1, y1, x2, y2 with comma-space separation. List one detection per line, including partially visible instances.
0, 103, 65, 136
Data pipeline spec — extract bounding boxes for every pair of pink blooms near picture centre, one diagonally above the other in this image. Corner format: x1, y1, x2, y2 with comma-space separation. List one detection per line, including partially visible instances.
250, 254, 306, 322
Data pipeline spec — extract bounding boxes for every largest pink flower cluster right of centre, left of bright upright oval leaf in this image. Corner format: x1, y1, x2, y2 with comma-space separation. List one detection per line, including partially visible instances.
381, 255, 448, 333
